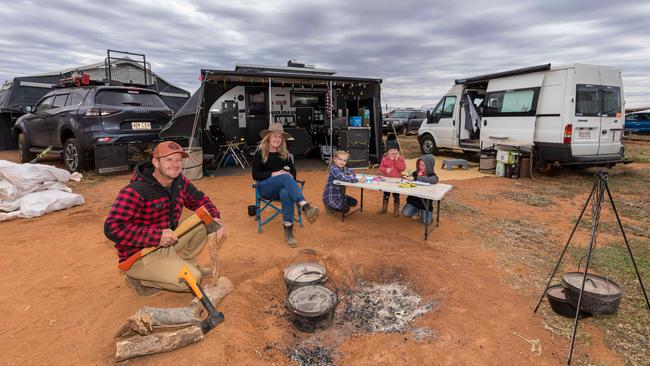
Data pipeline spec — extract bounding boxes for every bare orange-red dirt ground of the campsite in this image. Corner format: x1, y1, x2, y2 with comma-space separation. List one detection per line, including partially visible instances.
0, 150, 622, 365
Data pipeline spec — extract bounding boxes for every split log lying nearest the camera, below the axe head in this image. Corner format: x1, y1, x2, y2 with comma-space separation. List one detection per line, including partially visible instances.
115, 325, 203, 362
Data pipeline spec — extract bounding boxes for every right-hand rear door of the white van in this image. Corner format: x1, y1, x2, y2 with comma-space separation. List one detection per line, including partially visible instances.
598, 67, 625, 155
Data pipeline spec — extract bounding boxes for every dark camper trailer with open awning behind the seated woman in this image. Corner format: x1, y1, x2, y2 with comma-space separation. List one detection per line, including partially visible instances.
161, 61, 382, 167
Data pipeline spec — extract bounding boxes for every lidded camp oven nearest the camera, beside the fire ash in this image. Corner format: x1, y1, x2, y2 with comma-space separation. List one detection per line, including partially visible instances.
287, 285, 339, 333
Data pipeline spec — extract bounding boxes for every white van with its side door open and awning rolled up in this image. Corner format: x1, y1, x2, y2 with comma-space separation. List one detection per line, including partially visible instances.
418, 64, 629, 166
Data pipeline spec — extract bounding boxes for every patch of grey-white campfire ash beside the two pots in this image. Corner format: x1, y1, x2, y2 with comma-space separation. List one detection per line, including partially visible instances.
343, 282, 435, 333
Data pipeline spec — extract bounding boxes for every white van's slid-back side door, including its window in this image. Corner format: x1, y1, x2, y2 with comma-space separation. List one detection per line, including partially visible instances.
481, 72, 544, 144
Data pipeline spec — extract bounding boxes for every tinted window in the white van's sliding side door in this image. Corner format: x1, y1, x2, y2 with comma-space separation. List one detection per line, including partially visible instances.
485, 88, 539, 117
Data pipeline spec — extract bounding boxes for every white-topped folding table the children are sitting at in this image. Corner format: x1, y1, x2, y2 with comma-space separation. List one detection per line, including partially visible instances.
334, 178, 452, 240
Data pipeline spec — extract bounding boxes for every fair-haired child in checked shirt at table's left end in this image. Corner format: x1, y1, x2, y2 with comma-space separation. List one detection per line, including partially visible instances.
323, 150, 366, 213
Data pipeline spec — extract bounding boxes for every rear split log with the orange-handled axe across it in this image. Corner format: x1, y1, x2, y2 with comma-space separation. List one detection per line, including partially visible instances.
115, 277, 233, 338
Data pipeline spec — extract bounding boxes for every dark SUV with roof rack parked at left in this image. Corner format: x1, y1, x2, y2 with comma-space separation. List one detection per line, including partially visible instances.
13, 85, 173, 172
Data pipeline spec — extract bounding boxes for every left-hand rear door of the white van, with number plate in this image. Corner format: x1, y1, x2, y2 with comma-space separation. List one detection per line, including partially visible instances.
571, 65, 600, 156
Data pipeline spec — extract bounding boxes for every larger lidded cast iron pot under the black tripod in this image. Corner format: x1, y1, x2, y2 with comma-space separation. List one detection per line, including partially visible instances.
562, 272, 623, 315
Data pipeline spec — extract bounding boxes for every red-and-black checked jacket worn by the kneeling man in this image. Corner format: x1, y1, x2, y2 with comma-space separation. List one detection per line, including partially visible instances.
104, 162, 219, 262
